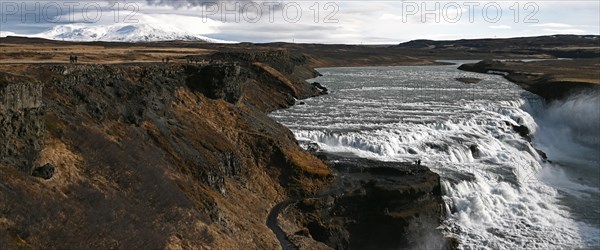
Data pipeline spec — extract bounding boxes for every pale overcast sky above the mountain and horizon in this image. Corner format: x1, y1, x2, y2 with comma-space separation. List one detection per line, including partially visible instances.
0, 0, 600, 44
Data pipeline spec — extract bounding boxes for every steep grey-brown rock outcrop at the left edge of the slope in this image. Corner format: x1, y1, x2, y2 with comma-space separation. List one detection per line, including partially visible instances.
0, 72, 44, 173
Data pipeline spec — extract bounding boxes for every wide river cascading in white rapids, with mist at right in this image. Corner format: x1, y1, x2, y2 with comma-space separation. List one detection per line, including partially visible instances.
271, 61, 600, 249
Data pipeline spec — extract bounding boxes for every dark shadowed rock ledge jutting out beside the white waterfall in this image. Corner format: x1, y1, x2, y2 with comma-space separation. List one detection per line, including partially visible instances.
287, 155, 450, 249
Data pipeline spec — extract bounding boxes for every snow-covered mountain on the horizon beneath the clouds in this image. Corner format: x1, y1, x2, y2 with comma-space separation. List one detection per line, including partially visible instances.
33, 23, 231, 43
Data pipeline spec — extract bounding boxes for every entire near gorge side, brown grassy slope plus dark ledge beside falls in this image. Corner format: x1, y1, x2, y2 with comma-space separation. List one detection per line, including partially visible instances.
0, 50, 444, 249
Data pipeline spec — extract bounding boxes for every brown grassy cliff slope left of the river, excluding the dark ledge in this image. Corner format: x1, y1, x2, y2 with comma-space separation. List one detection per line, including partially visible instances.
0, 51, 331, 249
